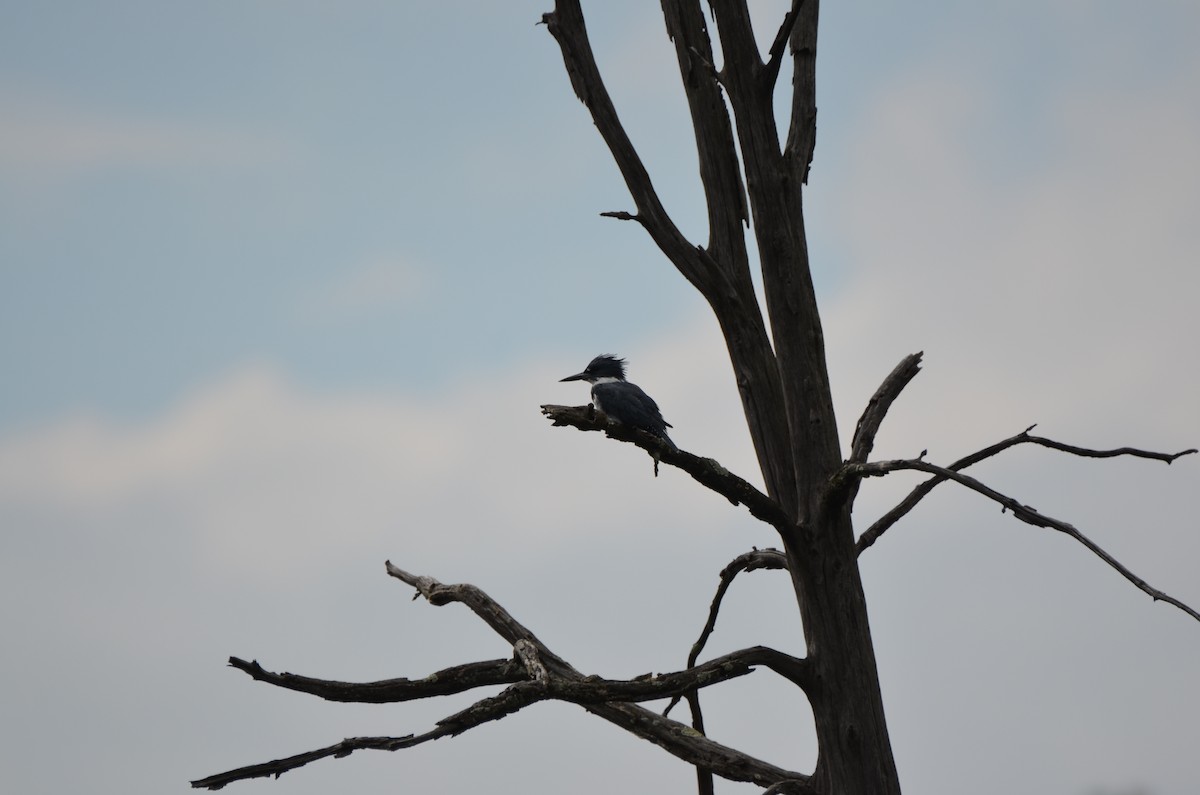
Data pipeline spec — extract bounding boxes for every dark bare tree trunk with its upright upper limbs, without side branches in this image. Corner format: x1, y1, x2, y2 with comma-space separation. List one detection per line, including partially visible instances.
547, 0, 900, 795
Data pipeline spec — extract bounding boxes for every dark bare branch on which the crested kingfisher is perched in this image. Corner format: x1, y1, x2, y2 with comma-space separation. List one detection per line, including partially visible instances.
541, 405, 791, 532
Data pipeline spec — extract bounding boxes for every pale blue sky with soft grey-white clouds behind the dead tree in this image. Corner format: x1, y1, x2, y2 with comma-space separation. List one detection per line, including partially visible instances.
0, 0, 1200, 795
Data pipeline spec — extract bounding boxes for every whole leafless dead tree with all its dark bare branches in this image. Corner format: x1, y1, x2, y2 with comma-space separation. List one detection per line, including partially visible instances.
192, 0, 1200, 795
